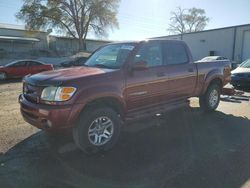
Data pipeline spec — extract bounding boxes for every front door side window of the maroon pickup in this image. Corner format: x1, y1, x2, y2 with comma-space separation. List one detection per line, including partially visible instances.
134, 42, 163, 67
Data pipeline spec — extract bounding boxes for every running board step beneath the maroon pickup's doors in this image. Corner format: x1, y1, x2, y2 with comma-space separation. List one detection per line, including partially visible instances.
125, 100, 189, 121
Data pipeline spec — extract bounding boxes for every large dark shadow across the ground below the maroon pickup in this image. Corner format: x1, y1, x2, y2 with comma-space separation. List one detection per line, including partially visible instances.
0, 108, 250, 188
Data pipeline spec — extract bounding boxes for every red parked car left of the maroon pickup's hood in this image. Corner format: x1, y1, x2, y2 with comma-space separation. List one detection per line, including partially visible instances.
0, 59, 53, 80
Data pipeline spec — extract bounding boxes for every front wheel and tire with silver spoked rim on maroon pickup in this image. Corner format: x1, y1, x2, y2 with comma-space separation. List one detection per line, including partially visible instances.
73, 106, 121, 154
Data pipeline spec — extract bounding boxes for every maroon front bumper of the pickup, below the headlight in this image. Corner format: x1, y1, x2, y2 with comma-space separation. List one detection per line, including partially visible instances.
19, 95, 82, 130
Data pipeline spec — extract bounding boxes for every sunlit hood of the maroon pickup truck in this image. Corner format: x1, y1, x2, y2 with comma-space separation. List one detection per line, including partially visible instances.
24, 67, 114, 86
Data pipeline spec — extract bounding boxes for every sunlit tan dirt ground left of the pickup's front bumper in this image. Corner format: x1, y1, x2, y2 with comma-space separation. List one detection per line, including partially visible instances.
0, 80, 38, 153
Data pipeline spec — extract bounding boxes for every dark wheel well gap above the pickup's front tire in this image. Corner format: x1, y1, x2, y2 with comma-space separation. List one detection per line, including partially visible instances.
82, 97, 124, 119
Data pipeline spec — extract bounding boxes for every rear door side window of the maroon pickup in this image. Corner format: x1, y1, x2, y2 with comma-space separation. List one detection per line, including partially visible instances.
165, 43, 189, 64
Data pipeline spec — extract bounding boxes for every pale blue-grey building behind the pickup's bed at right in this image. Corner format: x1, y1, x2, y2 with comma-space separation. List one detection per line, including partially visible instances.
153, 24, 250, 62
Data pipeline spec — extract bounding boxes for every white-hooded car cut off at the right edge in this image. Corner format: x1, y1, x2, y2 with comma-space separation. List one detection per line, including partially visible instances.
231, 59, 250, 89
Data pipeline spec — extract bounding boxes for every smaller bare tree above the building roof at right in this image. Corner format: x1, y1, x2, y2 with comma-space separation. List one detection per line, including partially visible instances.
168, 7, 209, 34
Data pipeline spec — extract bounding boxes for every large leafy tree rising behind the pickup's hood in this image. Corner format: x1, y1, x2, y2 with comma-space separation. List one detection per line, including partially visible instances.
16, 0, 120, 50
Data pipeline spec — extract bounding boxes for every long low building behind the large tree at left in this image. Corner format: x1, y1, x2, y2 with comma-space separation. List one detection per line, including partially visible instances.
0, 23, 111, 57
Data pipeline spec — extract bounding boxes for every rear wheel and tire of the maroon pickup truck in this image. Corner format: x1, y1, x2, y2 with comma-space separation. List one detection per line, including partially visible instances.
199, 84, 221, 112
